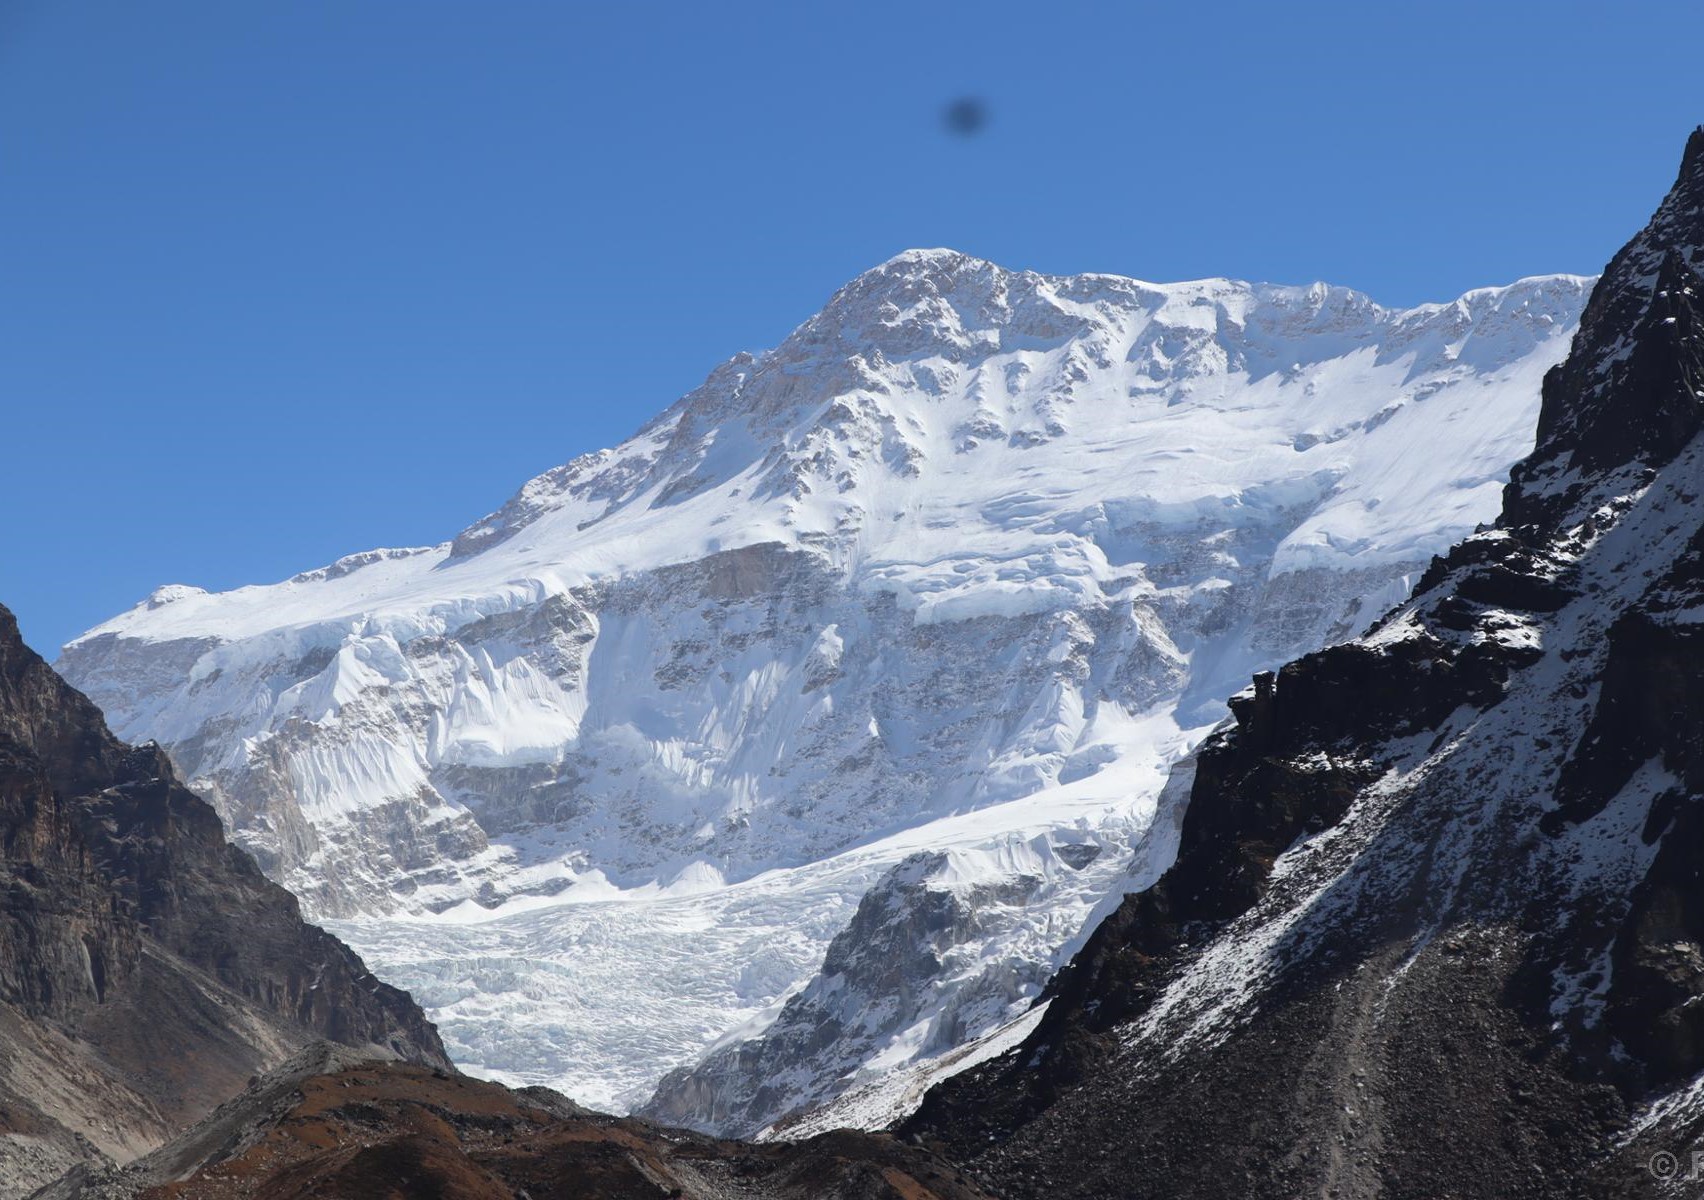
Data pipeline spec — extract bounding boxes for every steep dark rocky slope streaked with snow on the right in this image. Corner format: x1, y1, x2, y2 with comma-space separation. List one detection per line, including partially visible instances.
903, 131, 1704, 1200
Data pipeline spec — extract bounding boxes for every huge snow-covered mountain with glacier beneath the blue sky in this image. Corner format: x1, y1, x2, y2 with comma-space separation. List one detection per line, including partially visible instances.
61, 251, 1590, 1127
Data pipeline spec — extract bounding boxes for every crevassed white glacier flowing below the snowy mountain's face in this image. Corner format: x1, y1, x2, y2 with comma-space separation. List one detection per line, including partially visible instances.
327, 719, 1186, 1128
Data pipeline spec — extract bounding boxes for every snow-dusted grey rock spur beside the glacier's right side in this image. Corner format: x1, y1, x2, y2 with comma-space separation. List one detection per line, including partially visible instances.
641, 797, 1188, 1137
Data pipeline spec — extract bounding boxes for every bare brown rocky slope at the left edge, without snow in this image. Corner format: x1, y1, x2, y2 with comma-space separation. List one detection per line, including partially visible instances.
0, 609, 446, 1195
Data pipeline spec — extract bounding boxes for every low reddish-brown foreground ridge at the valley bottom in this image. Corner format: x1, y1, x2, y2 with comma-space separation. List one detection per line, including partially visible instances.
41, 1048, 990, 1200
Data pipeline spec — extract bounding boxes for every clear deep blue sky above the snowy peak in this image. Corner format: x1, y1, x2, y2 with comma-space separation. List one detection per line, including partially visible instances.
0, 0, 1704, 656
